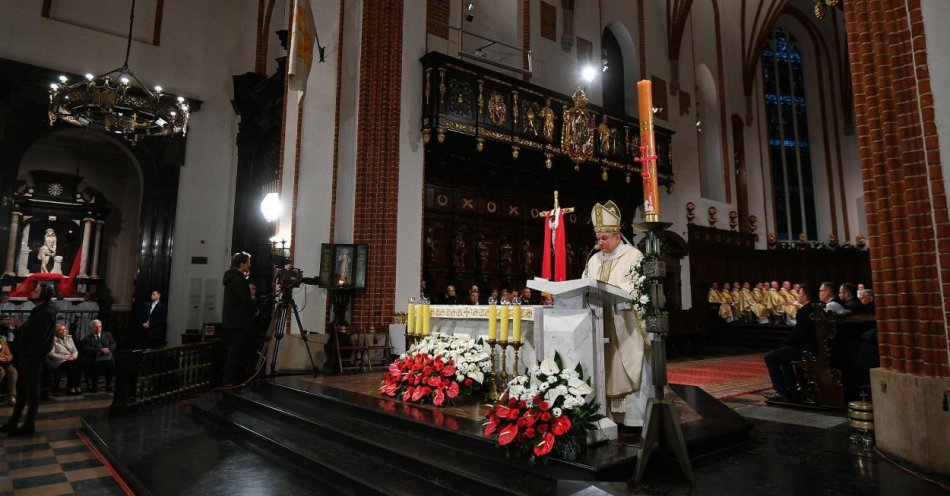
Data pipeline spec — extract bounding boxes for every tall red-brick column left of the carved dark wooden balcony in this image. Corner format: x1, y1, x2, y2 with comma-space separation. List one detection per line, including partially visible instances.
351, 0, 406, 329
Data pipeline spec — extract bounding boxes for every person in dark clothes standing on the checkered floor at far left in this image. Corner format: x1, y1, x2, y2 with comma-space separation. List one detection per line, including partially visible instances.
0, 284, 57, 436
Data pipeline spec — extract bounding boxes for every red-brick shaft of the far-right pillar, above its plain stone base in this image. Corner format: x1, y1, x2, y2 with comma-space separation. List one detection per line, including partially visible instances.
845, 0, 950, 377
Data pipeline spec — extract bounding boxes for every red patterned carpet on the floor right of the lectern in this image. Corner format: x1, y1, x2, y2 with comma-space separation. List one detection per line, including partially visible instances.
667, 353, 772, 399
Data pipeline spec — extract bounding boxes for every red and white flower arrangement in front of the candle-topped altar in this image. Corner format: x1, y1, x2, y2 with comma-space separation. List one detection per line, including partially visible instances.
379, 335, 491, 406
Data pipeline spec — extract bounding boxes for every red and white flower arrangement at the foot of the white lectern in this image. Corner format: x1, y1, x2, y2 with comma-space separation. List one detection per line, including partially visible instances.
484, 354, 603, 461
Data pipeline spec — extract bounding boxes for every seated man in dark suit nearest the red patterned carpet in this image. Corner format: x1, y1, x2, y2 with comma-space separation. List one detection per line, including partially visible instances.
765, 284, 817, 401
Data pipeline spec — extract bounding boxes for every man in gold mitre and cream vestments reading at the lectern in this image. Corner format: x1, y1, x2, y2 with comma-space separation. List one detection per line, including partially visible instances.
584, 201, 653, 427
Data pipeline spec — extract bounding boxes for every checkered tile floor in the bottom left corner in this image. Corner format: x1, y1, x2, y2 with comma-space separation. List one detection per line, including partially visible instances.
0, 393, 126, 496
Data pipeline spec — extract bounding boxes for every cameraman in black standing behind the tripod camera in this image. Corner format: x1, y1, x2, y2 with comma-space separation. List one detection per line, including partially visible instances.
222, 251, 256, 385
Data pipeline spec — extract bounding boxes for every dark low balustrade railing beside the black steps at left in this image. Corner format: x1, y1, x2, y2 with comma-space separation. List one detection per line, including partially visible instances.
109, 341, 223, 415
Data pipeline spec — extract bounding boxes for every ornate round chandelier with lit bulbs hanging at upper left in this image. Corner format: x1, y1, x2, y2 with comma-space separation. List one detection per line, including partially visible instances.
49, 0, 190, 144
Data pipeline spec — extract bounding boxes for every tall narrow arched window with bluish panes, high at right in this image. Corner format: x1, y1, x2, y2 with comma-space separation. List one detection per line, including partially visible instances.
762, 28, 818, 240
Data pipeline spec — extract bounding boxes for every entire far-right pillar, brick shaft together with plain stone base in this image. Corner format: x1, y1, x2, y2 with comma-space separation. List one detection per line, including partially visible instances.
845, 0, 950, 473
